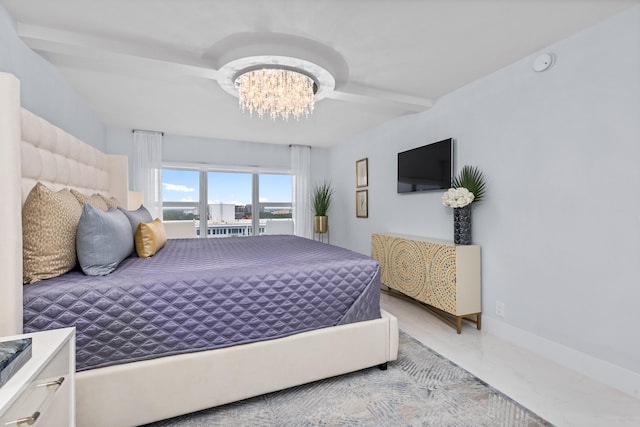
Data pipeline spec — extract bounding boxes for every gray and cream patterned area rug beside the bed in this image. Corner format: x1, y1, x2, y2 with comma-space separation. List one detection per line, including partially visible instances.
142, 332, 551, 427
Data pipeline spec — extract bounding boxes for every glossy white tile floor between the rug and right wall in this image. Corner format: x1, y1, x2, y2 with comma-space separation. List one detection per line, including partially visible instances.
381, 294, 640, 427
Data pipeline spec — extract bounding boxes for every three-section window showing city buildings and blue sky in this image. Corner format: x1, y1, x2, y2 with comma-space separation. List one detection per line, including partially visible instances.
162, 168, 293, 237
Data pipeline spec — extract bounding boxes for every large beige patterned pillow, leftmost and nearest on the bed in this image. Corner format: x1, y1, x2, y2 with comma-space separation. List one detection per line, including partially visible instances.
22, 182, 82, 284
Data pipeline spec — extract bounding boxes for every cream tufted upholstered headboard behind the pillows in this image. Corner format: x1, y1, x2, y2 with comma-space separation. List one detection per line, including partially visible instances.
0, 73, 129, 336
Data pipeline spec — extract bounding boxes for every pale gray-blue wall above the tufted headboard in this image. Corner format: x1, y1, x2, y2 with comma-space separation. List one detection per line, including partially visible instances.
0, 5, 106, 151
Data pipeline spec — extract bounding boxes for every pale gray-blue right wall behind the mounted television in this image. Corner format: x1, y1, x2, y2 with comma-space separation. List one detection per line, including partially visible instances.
330, 7, 640, 397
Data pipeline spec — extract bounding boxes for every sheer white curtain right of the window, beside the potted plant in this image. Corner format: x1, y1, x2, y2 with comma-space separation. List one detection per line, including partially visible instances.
291, 145, 312, 239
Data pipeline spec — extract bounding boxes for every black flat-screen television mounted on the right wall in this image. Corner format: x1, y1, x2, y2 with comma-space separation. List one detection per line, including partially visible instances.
398, 138, 453, 193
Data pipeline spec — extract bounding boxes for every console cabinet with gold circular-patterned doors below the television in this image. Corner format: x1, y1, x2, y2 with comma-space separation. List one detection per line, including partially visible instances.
371, 234, 482, 333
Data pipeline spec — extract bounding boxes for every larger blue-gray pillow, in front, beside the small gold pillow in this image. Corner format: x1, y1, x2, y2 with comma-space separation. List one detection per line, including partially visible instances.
76, 203, 133, 276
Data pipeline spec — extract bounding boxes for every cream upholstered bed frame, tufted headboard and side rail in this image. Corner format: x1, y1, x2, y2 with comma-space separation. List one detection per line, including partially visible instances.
0, 73, 398, 427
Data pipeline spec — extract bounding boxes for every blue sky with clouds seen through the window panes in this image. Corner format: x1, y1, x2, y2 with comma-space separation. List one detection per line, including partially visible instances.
162, 169, 292, 205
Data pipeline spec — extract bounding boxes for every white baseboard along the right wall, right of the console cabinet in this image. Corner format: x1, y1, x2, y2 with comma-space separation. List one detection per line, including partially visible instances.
482, 316, 640, 399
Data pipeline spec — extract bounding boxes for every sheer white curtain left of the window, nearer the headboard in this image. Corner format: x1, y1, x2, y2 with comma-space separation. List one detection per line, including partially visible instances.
132, 130, 162, 219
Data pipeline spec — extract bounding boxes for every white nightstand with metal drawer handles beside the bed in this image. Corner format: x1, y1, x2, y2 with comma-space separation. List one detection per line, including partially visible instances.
0, 328, 76, 427
